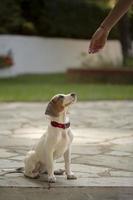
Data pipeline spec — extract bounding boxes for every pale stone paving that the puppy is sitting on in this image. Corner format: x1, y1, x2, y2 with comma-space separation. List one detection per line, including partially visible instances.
0, 101, 133, 200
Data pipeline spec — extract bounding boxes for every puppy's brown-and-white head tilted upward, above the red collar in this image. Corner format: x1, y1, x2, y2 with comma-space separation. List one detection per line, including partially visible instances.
45, 93, 77, 117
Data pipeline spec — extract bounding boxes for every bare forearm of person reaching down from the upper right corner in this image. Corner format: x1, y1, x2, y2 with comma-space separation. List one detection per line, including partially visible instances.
101, 0, 133, 31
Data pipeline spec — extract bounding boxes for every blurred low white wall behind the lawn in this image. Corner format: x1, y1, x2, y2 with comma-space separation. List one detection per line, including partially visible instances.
0, 35, 122, 77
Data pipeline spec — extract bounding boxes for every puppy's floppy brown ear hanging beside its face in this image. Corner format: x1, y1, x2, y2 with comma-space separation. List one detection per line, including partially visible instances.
45, 101, 59, 117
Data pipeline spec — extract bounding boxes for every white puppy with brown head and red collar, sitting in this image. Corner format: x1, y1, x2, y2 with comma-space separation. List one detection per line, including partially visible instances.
24, 93, 77, 183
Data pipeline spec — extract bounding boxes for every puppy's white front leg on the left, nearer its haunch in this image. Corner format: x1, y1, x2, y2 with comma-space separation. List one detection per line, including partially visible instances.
46, 152, 56, 183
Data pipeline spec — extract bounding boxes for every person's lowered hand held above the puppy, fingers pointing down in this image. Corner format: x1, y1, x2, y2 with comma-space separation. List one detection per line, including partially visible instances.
89, 27, 109, 53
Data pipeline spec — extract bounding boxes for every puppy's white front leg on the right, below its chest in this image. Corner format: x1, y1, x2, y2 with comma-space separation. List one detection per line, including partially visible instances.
64, 147, 77, 179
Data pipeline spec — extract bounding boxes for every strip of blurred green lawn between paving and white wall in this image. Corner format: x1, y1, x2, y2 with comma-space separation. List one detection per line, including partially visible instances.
0, 74, 133, 102
